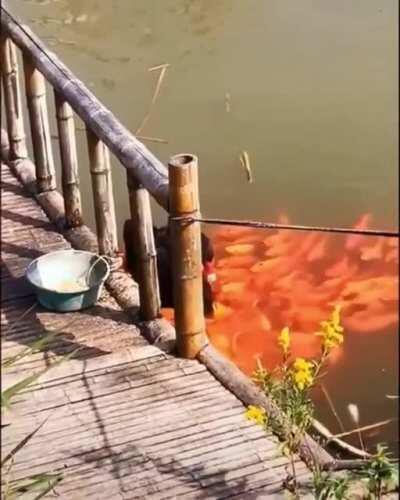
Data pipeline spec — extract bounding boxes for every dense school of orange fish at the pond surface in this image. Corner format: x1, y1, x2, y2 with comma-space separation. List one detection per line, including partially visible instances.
165, 214, 399, 374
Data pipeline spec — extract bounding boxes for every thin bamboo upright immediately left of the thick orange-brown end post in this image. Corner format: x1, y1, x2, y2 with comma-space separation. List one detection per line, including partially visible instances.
127, 172, 161, 321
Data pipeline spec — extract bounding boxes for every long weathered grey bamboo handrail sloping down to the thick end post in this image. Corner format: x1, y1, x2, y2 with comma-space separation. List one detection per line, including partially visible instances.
1, 7, 168, 210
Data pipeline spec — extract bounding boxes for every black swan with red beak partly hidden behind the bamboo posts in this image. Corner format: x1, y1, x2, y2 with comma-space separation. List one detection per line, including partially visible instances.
123, 223, 215, 316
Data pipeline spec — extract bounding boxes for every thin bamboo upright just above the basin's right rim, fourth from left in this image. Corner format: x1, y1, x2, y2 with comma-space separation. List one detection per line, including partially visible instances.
86, 128, 118, 257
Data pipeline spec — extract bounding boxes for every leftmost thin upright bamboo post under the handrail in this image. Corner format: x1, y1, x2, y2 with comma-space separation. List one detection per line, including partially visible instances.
1, 36, 28, 160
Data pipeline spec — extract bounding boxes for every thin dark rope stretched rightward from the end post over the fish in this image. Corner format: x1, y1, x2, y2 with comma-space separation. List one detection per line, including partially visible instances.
169, 216, 400, 238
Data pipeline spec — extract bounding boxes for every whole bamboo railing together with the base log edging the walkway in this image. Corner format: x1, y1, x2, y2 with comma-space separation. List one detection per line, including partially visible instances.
0, 7, 348, 467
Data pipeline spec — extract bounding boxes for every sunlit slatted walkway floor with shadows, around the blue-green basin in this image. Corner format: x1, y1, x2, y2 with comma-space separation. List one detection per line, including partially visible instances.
1, 165, 309, 500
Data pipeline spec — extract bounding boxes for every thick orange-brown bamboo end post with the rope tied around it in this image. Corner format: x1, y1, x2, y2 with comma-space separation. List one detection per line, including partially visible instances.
168, 154, 207, 358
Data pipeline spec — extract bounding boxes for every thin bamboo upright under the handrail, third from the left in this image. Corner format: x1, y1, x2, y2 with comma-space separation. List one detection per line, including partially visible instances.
54, 91, 82, 227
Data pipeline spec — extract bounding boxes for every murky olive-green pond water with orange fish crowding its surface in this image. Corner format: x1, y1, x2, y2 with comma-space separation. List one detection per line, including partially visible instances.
7, 0, 398, 452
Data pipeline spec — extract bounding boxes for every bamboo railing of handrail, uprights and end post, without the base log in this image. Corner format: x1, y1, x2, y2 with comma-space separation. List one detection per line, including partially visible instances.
1, 7, 207, 358
